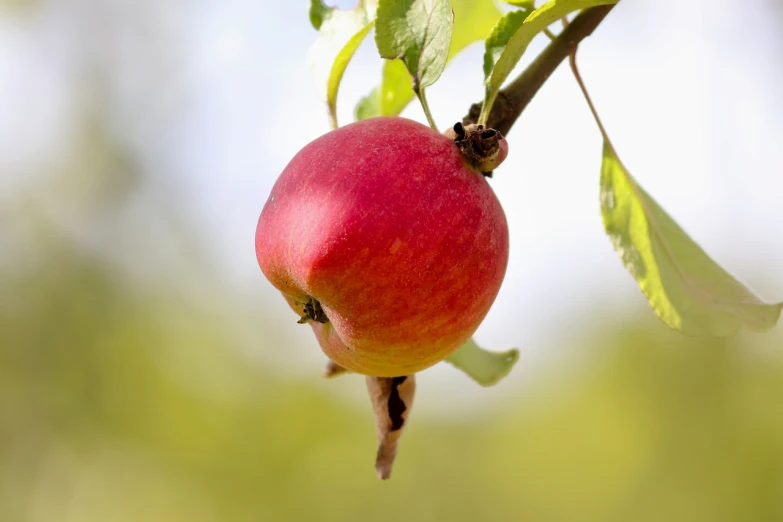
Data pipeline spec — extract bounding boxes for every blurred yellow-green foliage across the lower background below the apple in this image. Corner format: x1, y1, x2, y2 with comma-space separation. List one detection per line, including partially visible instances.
0, 176, 783, 522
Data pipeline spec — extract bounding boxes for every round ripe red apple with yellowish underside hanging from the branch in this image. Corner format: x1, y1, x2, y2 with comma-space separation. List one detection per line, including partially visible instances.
255, 117, 508, 377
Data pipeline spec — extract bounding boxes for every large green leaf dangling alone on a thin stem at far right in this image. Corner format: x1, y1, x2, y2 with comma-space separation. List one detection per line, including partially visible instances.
601, 140, 783, 336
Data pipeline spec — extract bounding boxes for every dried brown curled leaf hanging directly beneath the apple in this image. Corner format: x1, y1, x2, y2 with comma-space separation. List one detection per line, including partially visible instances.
366, 375, 416, 480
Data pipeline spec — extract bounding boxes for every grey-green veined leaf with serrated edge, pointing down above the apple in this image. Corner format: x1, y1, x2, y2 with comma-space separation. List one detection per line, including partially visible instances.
375, 0, 454, 91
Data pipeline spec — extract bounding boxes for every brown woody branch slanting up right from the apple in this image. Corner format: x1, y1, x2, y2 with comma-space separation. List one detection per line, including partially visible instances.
462, 4, 614, 135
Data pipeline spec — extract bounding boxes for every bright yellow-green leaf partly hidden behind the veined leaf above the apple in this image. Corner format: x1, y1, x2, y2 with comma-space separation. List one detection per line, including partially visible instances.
356, 0, 501, 120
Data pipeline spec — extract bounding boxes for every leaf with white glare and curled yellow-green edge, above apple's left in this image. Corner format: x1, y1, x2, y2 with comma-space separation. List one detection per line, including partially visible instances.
308, 0, 376, 128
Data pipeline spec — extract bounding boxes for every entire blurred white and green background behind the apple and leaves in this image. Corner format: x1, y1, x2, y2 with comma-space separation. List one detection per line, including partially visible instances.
0, 0, 783, 522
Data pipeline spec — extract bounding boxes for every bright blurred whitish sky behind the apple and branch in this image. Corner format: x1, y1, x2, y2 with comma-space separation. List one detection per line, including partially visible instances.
0, 0, 783, 400
